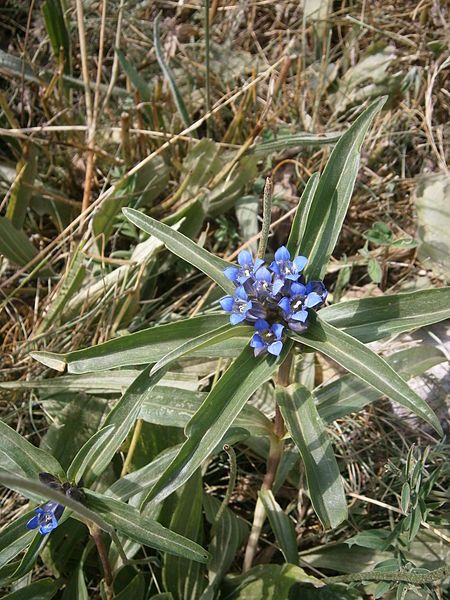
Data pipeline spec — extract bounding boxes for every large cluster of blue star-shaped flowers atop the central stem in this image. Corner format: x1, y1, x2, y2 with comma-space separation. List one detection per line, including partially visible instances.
220, 246, 327, 356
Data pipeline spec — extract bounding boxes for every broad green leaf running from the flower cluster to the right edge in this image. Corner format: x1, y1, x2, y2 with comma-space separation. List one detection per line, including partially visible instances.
320, 287, 450, 343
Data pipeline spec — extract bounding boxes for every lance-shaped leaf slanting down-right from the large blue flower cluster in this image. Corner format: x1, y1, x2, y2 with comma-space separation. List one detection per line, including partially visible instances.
290, 315, 442, 435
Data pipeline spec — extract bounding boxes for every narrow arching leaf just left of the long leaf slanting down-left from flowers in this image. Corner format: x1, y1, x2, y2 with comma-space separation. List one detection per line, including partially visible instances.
69, 365, 164, 485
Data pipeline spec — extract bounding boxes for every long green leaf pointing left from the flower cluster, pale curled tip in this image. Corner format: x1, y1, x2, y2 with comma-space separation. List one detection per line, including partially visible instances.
31, 314, 229, 373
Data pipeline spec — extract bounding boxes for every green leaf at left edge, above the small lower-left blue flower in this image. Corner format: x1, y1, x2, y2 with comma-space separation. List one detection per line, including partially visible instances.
0, 421, 64, 479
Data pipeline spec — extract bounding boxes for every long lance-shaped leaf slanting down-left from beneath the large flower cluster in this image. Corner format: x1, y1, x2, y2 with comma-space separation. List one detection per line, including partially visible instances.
145, 343, 291, 502
